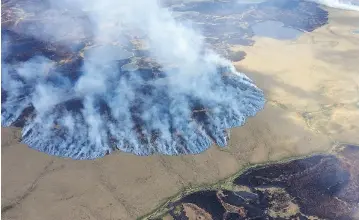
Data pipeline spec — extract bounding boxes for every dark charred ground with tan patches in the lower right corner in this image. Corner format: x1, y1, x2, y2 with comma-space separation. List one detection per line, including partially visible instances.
149, 145, 359, 220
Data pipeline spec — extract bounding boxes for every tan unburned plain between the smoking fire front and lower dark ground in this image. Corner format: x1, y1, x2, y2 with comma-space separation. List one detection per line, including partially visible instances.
1, 6, 359, 220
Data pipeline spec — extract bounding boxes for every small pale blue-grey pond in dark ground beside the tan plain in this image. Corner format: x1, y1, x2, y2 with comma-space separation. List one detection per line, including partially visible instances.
252, 21, 303, 40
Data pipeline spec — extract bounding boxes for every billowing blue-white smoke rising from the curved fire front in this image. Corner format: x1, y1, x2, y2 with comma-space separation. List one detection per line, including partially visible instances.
2, 0, 264, 159
